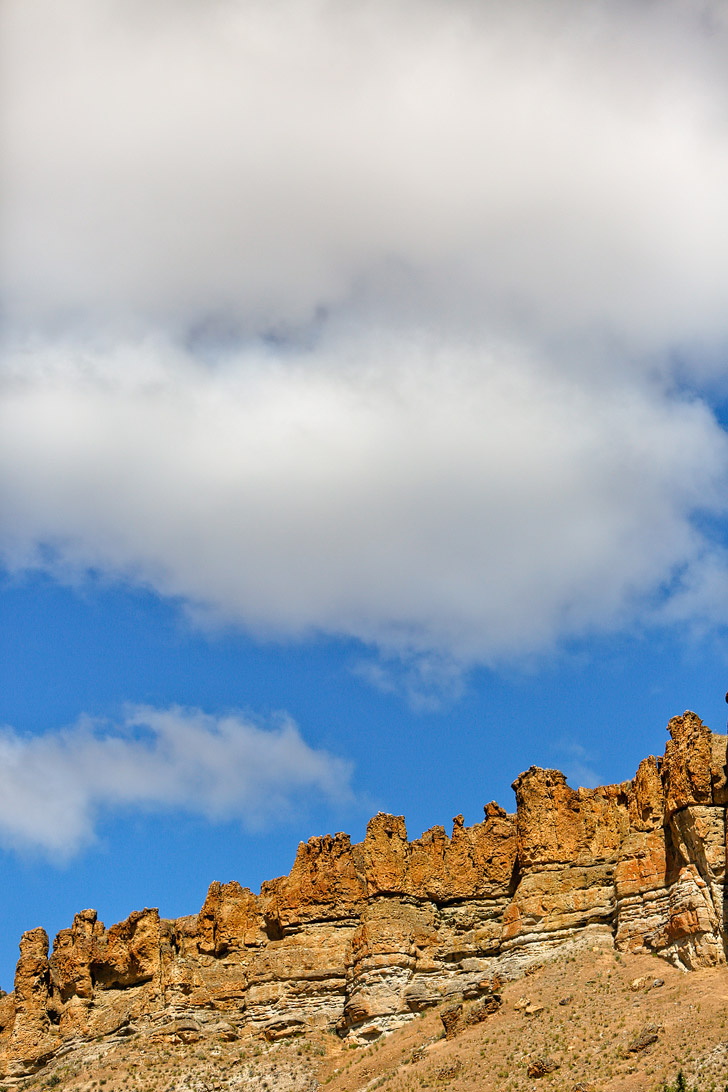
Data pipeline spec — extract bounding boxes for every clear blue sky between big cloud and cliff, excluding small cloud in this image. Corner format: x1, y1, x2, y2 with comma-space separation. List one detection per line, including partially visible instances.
0, 578, 728, 988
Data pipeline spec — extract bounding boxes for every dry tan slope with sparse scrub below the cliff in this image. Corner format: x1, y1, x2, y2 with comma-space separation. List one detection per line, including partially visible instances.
4, 949, 728, 1092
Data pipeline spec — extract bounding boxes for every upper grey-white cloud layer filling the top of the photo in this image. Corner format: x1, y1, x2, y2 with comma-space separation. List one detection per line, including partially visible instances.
0, 0, 728, 348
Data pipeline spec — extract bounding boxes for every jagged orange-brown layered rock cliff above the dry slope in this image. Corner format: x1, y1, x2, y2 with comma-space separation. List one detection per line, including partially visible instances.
0, 712, 728, 1077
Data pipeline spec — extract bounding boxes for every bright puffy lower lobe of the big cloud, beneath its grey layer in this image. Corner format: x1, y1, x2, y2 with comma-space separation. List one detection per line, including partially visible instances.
0, 335, 728, 662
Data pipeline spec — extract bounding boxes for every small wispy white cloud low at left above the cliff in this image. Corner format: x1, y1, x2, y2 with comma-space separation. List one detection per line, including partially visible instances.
0, 707, 351, 856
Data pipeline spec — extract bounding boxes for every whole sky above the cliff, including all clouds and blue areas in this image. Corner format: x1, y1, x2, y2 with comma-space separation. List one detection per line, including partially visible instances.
0, 0, 728, 989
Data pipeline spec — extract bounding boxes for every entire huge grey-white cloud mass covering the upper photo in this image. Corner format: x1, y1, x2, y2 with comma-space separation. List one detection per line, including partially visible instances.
0, 0, 728, 668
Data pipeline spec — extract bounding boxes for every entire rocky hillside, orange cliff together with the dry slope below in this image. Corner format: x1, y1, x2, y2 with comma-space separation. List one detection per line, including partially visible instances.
0, 712, 728, 1092
